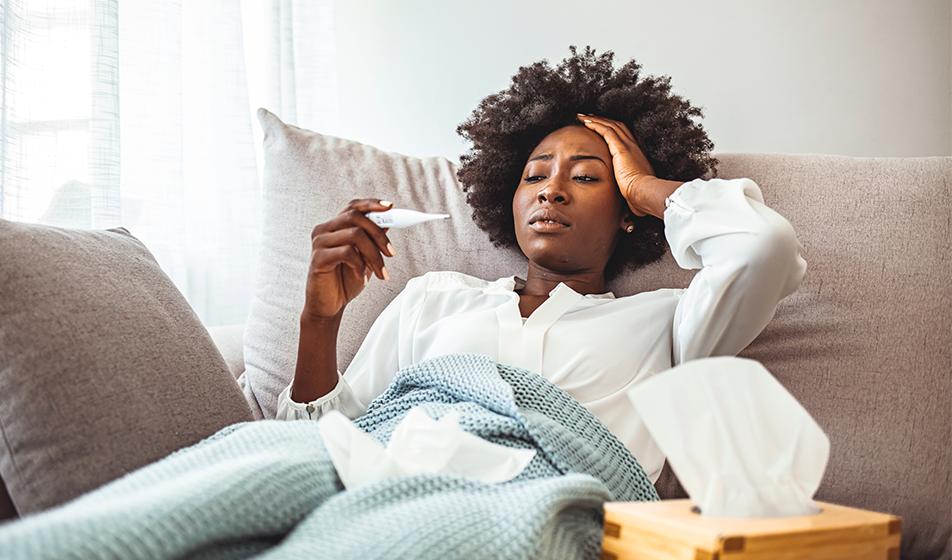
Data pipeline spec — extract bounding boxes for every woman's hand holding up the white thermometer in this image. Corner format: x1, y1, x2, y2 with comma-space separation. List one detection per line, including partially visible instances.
302, 198, 393, 321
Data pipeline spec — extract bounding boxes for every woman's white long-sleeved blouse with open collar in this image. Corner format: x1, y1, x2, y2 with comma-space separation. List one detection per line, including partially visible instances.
277, 179, 807, 482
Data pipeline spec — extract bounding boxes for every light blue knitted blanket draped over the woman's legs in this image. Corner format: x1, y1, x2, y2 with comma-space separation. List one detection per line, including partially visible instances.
0, 354, 658, 560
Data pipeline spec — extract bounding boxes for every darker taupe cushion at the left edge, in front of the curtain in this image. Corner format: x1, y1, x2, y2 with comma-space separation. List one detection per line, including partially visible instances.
0, 220, 252, 515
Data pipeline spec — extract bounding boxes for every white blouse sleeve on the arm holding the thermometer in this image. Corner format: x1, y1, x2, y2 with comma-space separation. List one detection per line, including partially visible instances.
276, 277, 425, 420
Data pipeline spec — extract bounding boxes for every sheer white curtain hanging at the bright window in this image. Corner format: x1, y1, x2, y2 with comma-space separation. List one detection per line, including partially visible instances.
0, 0, 338, 325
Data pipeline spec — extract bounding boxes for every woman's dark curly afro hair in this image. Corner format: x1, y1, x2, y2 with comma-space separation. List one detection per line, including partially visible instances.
456, 46, 718, 280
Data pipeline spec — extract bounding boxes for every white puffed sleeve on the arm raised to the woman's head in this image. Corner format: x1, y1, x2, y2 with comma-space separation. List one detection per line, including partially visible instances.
664, 179, 807, 365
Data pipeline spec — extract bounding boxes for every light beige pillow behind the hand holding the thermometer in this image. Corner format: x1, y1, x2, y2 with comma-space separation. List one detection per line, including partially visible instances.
242, 109, 526, 418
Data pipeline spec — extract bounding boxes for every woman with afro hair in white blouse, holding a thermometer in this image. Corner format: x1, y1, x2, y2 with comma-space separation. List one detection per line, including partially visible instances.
277, 47, 806, 482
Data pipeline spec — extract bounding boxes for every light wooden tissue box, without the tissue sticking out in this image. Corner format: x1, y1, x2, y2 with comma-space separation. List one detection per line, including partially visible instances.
602, 500, 902, 560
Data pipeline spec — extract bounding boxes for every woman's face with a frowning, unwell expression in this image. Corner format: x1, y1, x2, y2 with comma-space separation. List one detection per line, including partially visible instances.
512, 125, 628, 273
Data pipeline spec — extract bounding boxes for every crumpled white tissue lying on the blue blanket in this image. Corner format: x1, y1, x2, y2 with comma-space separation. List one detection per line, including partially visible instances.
317, 407, 535, 490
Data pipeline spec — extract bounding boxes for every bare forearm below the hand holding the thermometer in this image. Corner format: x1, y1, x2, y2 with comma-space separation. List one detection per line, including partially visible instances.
291, 316, 340, 403
